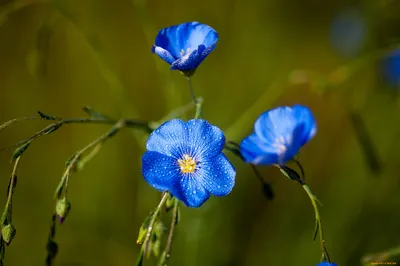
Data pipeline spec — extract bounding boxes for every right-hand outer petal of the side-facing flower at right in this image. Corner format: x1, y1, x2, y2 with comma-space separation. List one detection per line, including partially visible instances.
293, 105, 317, 147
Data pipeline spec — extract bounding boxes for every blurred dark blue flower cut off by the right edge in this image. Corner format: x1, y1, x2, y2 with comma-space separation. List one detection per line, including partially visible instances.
382, 49, 400, 88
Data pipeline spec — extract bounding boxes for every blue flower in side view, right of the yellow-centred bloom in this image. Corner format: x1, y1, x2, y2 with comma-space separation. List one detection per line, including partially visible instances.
240, 105, 317, 165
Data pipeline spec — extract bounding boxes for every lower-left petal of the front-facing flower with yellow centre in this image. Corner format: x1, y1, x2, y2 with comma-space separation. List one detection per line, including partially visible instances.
142, 151, 180, 191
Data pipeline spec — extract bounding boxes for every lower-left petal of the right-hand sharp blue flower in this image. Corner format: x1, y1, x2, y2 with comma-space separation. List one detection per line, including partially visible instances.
240, 133, 279, 165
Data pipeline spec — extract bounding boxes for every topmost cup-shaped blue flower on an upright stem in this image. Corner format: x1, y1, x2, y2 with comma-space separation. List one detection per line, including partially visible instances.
152, 22, 218, 74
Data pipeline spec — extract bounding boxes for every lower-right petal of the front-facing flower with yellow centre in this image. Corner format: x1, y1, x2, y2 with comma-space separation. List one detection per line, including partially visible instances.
196, 153, 236, 196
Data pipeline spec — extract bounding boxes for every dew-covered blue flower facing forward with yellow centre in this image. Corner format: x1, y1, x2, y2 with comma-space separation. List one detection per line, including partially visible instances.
142, 119, 236, 207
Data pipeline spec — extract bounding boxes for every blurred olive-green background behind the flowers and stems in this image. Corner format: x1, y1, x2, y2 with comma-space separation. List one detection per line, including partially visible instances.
0, 0, 400, 266
